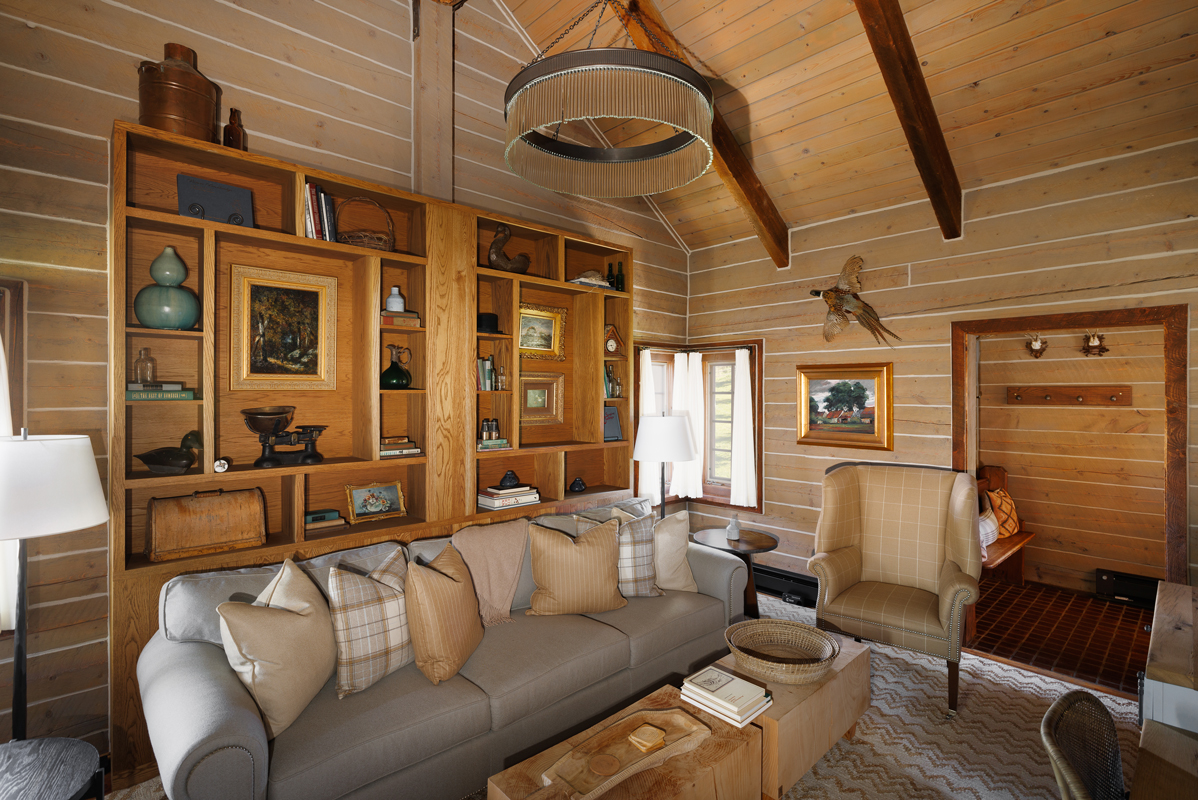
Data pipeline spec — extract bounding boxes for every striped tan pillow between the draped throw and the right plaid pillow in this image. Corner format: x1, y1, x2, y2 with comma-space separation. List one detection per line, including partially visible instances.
525, 520, 628, 617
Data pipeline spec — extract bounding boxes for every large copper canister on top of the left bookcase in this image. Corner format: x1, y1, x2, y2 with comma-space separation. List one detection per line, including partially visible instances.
138, 44, 220, 143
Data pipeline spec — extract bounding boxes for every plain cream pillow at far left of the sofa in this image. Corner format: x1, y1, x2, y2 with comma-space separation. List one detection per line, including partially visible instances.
217, 558, 337, 739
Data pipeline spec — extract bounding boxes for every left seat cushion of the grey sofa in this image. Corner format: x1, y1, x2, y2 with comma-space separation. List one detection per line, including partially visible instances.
267, 663, 491, 800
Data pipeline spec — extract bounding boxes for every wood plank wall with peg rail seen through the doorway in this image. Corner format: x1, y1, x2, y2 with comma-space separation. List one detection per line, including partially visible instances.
978, 326, 1164, 592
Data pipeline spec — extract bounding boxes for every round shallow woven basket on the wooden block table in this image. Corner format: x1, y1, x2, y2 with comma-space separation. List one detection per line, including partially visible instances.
724, 619, 840, 684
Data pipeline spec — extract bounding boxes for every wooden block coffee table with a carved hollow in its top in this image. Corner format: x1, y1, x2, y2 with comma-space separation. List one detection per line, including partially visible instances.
486, 686, 762, 800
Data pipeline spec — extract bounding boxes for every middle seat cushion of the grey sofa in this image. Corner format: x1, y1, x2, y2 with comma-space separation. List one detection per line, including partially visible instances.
459, 614, 628, 731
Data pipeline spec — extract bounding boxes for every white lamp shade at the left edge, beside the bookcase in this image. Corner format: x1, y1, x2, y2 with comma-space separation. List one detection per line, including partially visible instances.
0, 436, 108, 539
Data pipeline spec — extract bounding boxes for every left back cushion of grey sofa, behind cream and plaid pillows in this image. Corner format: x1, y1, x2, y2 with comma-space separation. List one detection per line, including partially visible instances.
158, 541, 399, 646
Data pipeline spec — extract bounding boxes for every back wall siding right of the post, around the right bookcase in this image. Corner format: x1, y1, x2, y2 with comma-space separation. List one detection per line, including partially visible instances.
454, 0, 686, 343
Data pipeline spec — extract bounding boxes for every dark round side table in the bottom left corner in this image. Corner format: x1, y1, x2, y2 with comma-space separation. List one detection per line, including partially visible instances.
0, 738, 104, 800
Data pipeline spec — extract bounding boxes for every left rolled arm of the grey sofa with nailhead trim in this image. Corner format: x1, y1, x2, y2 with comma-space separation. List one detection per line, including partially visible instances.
138, 630, 268, 800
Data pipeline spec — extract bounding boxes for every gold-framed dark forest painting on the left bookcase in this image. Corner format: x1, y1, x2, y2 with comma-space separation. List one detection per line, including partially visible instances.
229, 263, 337, 390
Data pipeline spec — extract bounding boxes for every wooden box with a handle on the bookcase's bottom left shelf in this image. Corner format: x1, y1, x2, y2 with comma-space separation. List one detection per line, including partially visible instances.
146, 489, 266, 562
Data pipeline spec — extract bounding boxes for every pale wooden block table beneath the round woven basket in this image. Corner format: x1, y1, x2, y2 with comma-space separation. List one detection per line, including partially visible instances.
718, 637, 870, 799
